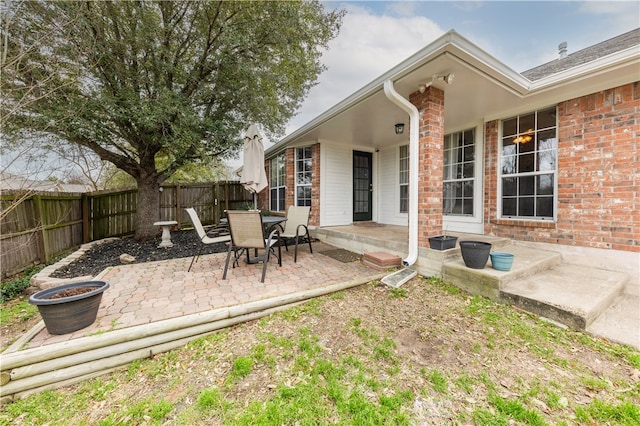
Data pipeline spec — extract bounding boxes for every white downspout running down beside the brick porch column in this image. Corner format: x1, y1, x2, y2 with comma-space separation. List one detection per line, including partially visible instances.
384, 80, 420, 266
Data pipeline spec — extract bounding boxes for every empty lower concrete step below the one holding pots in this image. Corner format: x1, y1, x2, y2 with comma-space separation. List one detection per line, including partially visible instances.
500, 264, 628, 330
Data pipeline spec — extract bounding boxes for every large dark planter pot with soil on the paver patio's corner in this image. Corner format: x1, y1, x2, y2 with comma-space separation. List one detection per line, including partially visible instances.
29, 281, 109, 334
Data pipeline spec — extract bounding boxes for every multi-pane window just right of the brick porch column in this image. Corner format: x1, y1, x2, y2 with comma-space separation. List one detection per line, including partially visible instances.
442, 129, 476, 216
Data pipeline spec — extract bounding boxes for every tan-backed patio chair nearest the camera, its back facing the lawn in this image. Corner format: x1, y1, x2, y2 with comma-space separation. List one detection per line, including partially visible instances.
222, 210, 282, 283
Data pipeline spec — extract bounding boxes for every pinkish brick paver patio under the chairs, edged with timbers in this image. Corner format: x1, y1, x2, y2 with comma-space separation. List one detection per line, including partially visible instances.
28, 243, 384, 348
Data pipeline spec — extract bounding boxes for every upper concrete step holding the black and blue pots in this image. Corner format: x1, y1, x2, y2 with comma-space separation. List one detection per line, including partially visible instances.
442, 243, 562, 300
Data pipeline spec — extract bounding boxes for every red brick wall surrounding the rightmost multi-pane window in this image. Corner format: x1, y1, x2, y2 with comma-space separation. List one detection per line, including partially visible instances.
484, 82, 640, 252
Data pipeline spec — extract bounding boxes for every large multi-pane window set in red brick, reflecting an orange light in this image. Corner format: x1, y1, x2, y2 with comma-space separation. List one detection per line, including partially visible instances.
500, 107, 558, 219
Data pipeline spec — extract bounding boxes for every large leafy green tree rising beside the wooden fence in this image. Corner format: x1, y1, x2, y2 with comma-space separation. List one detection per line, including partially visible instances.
0, 0, 343, 238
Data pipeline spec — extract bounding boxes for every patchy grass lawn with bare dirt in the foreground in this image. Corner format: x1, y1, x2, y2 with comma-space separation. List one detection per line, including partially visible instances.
0, 277, 640, 425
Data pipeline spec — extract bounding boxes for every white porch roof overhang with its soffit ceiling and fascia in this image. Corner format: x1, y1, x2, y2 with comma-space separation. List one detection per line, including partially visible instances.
268, 32, 639, 153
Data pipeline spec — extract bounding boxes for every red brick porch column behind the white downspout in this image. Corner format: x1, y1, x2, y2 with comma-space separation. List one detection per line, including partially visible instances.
409, 86, 444, 248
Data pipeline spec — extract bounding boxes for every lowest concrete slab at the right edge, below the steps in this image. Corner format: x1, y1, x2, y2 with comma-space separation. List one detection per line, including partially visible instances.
587, 292, 640, 349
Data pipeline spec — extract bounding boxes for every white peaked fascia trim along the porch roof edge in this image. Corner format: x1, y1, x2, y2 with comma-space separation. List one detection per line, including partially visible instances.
265, 30, 530, 155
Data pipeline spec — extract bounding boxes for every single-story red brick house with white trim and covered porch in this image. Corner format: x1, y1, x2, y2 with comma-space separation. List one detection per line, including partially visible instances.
260, 28, 640, 276
